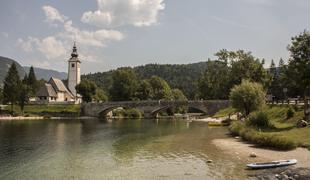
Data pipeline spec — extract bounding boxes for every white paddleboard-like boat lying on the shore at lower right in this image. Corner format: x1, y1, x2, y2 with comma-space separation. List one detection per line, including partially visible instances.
246, 159, 297, 169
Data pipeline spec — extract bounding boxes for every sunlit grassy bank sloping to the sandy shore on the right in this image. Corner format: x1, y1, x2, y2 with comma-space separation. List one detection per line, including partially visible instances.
229, 105, 310, 150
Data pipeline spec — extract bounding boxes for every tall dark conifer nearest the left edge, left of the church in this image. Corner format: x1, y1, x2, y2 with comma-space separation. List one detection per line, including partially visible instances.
3, 63, 21, 113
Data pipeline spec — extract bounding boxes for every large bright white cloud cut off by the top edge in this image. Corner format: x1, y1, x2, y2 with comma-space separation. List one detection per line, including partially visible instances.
81, 0, 165, 27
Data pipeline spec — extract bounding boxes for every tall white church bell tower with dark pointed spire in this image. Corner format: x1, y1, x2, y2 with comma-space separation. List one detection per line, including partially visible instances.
68, 42, 81, 97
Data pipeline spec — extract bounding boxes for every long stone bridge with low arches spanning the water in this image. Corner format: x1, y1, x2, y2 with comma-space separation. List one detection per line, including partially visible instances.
82, 100, 229, 117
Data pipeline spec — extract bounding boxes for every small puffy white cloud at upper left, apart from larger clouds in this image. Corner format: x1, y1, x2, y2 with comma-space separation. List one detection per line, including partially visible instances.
42, 6, 67, 26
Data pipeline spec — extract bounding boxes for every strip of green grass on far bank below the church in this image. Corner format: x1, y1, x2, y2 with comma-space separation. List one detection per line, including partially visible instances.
6, 104, 81, 115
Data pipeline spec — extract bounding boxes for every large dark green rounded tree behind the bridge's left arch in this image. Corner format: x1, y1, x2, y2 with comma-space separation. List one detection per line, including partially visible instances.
110, 68, 138, 101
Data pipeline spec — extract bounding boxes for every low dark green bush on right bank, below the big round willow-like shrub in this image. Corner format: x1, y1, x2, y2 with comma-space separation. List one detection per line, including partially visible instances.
247, 111, 272, 128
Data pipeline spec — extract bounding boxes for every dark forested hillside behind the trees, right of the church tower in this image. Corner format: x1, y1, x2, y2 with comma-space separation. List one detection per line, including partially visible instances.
82, 62, 207, 99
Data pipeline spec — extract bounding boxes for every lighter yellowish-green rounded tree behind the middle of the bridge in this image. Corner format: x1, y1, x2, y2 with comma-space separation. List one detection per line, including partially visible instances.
148, 76, 173, 100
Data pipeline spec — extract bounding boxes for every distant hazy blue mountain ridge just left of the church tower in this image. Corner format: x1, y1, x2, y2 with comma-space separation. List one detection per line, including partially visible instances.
24, 66, 68, 81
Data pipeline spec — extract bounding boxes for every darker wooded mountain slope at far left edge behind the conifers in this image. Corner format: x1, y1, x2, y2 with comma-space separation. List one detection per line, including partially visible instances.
0, 56, 25, 87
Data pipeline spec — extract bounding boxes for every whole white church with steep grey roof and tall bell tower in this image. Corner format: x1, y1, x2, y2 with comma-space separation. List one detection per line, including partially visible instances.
35, 43, 82, 104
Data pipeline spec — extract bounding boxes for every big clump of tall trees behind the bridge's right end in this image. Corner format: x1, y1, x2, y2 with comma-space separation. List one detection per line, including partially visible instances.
198, 49, 268, 99
